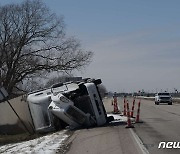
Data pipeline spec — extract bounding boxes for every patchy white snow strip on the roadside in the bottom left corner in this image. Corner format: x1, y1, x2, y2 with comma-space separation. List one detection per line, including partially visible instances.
0, 130, 69, 154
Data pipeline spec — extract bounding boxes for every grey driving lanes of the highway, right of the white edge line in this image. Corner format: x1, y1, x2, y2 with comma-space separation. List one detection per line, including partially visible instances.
118, 98, 180, 154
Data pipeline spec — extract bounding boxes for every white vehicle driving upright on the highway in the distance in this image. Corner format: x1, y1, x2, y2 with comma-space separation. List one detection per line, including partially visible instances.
155, 92, 172, 105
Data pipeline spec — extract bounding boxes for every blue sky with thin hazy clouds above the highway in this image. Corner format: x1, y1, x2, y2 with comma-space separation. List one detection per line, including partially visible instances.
0, 0, 180, 92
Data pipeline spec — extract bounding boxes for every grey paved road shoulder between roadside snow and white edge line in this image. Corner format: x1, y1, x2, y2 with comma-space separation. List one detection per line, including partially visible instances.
64, 99, 143, 154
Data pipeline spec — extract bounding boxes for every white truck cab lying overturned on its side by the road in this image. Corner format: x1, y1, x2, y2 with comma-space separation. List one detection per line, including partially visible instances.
27, 79, 113, 132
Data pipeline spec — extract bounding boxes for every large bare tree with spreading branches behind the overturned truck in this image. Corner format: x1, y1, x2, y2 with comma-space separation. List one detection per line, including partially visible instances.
0, 0, 92, 93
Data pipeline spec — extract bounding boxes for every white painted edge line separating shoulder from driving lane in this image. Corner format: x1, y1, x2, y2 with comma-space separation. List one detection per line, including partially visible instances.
130, 128, 149, 154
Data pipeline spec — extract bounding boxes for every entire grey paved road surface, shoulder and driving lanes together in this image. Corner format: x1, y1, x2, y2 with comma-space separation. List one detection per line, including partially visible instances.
64, 98, 180, 154
